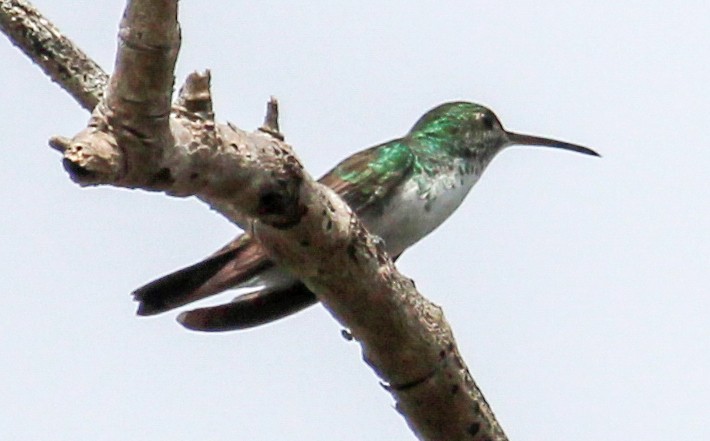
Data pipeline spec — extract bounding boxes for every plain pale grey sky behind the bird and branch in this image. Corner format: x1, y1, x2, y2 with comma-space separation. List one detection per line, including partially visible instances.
0, 0, 710, 441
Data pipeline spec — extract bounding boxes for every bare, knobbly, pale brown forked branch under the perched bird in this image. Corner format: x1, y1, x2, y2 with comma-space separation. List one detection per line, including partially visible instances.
0, 0, 507, 441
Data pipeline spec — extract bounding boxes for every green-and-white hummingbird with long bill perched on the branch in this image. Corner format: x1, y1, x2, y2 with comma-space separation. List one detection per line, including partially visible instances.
133, 101, 599, 331
